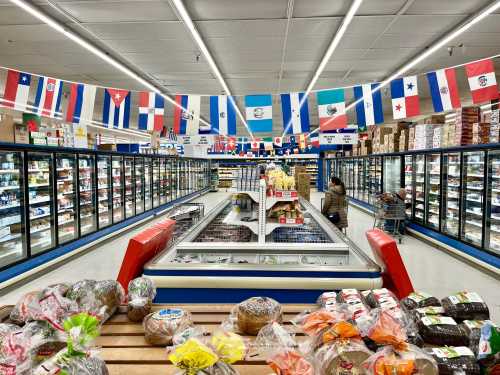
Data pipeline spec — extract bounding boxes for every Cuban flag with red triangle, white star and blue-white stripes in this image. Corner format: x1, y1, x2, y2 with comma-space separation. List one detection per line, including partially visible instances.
102, 89, 131, 129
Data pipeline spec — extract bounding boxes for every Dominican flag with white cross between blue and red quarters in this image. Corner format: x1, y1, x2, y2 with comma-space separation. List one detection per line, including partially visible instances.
139, 91, 165, 132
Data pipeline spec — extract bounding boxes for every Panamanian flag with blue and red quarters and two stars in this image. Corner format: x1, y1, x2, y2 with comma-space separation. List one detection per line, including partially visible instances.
391, 76, 420, 120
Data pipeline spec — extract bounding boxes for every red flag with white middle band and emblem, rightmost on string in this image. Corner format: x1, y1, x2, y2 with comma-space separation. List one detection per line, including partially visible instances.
465, 59, 498, 104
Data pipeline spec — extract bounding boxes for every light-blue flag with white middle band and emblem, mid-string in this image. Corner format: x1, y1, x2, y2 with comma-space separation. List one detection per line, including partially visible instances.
245, 95, 273, 133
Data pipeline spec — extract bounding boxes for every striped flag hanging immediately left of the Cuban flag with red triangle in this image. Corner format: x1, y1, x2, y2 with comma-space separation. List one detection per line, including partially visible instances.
66, 83, 97, 124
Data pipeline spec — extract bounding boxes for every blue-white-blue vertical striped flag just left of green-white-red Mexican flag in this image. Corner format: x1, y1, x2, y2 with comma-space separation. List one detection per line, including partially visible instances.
281, 92, 309, 134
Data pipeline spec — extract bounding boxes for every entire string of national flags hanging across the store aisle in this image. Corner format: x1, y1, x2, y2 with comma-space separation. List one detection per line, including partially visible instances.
0, 56, 499, 141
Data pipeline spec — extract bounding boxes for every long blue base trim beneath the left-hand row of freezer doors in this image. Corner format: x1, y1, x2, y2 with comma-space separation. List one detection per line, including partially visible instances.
0, 189, 208, 283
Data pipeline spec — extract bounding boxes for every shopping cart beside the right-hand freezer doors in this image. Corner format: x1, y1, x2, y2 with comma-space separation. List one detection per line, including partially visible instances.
372, 193, 406, 243
